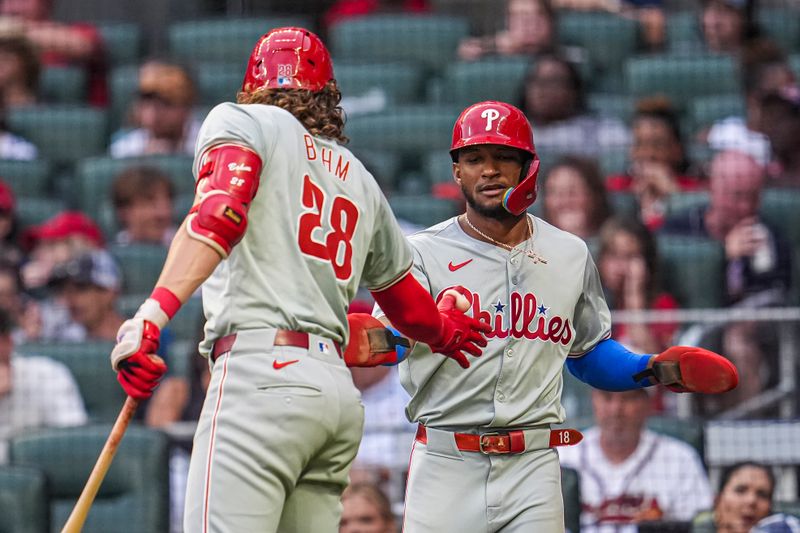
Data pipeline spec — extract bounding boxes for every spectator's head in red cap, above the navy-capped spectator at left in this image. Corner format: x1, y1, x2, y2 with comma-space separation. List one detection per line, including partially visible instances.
22, 211, 104, 290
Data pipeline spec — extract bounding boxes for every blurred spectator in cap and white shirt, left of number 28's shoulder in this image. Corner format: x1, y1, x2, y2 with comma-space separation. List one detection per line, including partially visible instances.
109, 60, 200, 157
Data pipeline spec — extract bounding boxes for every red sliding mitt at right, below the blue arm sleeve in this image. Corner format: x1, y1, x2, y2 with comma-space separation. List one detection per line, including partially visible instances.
633, 346, 739, 394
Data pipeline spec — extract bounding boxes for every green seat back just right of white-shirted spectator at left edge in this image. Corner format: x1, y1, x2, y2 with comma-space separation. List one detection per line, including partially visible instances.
16, 341, 125, 422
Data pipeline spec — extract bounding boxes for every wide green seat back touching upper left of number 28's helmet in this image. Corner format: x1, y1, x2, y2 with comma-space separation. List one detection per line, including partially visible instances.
168, 16, 312, 64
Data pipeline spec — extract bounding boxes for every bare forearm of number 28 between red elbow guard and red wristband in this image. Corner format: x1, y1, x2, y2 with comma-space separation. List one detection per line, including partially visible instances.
156, 223, 222, 303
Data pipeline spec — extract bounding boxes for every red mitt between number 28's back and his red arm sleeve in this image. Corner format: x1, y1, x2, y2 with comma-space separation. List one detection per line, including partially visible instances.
344, 313, 411, 367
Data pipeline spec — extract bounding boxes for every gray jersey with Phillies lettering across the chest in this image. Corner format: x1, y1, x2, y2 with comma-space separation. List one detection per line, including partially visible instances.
376, 215, 611, 428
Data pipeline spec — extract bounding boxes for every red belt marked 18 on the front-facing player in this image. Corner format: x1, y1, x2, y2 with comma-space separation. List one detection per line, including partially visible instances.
416, 424, 583, 455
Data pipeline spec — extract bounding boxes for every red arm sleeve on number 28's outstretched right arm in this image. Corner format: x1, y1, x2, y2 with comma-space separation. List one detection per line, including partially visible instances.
372, 272, 443, 344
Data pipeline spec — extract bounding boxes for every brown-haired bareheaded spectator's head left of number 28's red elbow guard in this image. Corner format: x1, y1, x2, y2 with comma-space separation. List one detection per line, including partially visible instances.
111, 166, 177, 246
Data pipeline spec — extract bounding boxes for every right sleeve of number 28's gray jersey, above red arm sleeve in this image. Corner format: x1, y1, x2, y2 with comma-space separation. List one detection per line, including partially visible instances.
361, 192, 412, 291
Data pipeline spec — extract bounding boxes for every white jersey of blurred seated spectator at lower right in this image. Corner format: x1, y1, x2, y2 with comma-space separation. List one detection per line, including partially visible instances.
558, 428, 713, 533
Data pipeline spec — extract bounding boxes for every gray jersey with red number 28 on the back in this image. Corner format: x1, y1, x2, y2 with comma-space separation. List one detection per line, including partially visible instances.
194, 103, 412, 354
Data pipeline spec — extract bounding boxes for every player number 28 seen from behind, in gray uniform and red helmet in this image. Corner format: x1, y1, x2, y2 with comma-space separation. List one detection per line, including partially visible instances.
111, 28, 488, 533
